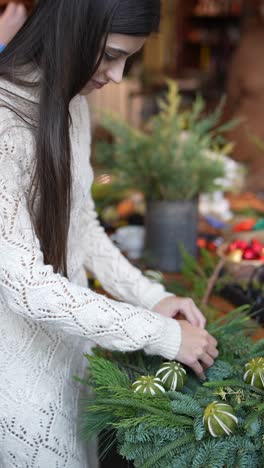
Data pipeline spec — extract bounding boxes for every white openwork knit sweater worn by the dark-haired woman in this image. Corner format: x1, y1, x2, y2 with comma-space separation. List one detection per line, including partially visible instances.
0, 80, 181, 468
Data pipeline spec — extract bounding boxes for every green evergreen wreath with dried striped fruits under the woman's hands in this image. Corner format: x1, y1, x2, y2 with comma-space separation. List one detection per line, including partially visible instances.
79, 307, 264, 468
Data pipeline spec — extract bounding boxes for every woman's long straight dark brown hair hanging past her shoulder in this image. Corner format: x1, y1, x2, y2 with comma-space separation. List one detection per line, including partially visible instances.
0, 0, 160, 276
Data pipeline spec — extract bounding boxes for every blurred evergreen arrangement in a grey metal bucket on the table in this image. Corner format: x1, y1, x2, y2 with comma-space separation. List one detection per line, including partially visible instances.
96, 80, 235, 271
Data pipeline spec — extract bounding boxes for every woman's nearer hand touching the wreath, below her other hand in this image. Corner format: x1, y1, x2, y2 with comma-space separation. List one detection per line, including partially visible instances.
176, 320, 219, 380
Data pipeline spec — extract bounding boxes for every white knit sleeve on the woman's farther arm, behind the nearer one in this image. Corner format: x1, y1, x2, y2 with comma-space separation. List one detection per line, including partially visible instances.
79, 197, 171, 309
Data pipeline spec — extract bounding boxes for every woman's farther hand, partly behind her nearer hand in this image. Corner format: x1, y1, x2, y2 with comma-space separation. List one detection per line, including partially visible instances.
153, 296, 206, 328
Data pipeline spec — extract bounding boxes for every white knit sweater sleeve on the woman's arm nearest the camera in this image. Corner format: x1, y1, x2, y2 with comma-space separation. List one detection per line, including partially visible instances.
0, 122, 181, 358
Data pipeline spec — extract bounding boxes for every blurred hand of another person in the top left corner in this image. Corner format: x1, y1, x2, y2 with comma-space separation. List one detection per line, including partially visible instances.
0, 2, 27, 45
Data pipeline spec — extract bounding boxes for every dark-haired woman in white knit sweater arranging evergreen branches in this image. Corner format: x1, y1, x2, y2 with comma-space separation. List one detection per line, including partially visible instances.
0, 0, 218, 468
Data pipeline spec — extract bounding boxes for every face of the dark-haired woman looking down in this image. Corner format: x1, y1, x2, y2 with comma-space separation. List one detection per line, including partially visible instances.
82, 34, 146, 94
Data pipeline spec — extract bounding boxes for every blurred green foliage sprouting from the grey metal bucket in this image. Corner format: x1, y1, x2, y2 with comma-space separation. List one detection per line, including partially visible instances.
96, 81, 234, 200
